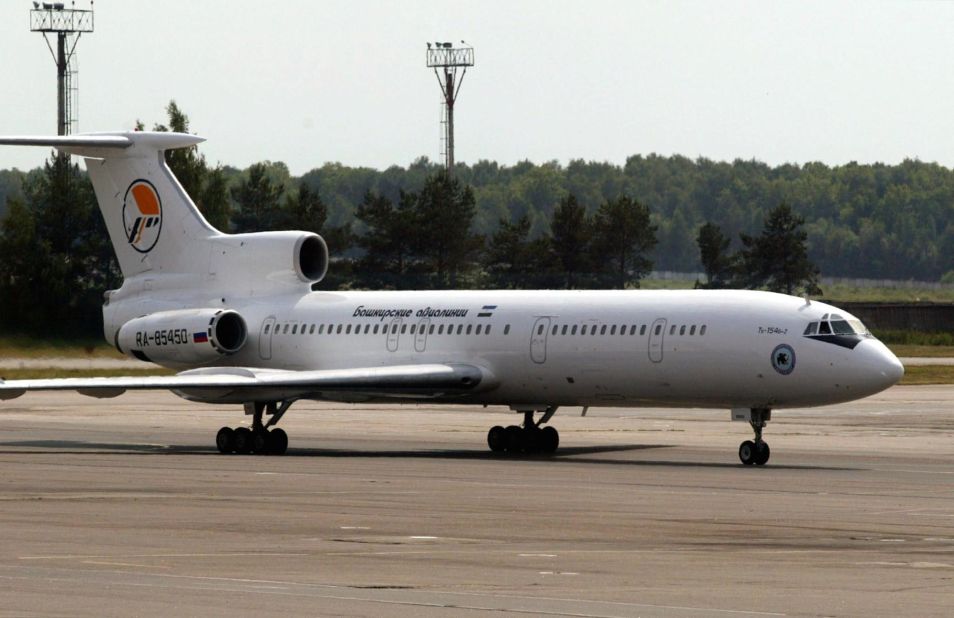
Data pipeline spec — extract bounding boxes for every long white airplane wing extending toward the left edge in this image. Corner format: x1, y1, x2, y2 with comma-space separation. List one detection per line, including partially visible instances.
0, 363, 497, 403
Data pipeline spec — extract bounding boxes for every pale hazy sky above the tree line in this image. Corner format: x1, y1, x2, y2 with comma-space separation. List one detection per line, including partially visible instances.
0, 0, 954, 175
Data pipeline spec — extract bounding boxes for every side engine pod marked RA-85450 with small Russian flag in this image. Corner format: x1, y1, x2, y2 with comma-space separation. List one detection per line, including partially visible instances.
116, 309, 248, 366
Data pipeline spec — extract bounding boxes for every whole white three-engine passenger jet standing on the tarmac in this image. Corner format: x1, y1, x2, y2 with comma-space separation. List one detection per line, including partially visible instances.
0, 131, 904, 465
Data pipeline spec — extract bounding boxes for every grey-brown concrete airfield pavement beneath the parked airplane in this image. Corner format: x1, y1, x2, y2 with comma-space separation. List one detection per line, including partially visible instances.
0, 386, 954, 617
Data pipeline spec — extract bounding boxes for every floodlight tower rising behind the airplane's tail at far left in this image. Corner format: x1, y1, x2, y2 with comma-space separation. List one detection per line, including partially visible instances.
30, 1, 93, 135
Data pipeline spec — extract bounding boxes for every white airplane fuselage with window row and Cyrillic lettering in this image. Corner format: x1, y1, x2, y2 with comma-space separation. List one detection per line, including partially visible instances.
128, 290, 903, 409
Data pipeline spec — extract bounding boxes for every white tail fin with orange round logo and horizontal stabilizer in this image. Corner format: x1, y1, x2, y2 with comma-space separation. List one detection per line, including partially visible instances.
0, 131, 221, 278
